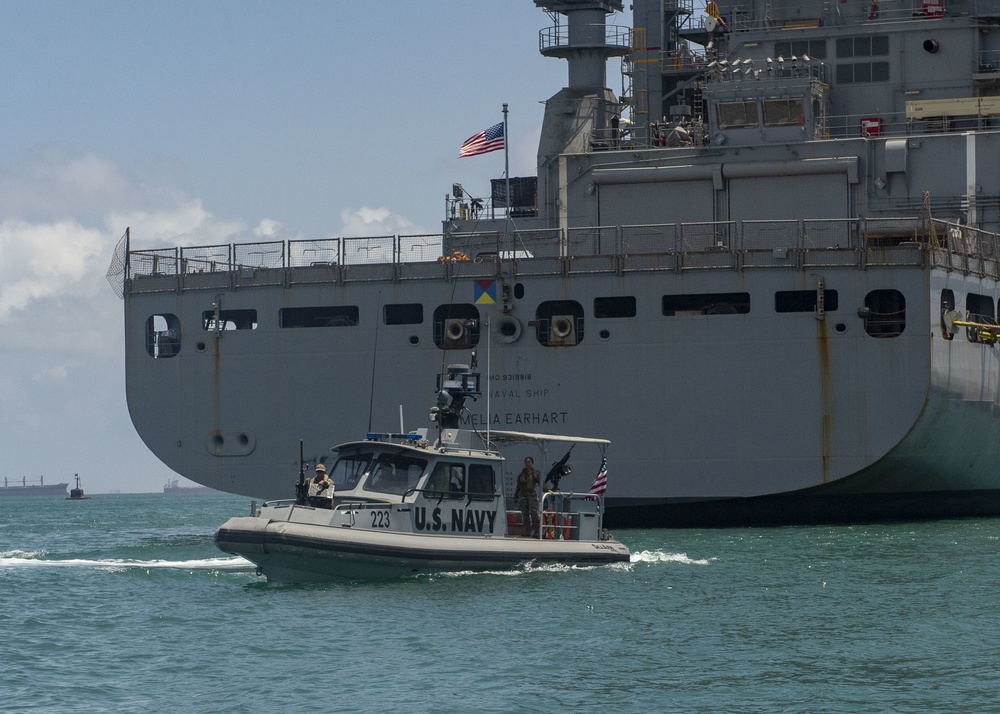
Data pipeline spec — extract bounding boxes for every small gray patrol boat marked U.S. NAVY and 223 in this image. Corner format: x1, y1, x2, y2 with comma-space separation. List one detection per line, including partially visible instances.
215, 362, 630, 582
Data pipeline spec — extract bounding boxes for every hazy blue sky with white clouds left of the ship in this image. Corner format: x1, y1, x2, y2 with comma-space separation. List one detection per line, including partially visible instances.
0, 0, 630, 494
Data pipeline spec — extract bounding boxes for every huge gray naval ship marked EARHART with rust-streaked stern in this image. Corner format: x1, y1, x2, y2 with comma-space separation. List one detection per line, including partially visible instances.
109, 0, 1000, 527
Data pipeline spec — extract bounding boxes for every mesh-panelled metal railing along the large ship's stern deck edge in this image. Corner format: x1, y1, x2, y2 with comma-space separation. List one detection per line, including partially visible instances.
119, 217, 1000, 293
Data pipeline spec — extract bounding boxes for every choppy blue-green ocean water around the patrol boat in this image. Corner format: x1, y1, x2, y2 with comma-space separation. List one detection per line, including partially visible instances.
0, 493, 1000, 714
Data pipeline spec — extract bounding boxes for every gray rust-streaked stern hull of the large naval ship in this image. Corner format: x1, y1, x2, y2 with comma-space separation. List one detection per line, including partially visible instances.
126, 249, 1000, 527
